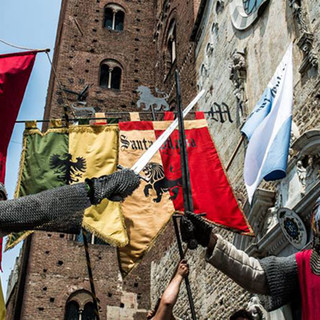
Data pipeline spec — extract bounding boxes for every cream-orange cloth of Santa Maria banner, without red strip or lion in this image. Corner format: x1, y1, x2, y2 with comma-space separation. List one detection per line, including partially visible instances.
118, 122, 174, 276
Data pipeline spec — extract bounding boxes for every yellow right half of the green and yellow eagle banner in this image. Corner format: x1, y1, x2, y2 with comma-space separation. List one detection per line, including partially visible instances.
69, 125, 128, 246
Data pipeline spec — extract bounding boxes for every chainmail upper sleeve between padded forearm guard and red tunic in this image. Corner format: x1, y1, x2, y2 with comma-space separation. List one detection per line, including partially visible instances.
259, 255, 300, 311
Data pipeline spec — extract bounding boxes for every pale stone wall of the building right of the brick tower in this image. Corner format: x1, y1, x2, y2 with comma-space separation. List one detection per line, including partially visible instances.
147, 1, 320, 320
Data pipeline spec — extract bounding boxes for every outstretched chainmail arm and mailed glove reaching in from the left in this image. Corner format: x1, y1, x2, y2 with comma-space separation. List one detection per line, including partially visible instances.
0, 169, 140, 237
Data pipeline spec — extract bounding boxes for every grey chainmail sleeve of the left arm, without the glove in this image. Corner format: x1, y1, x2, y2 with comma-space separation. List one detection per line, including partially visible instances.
0, 183, 91, 233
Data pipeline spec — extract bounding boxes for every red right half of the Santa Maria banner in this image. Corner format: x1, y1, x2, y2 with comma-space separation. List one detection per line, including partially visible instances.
156, 120, 253, 234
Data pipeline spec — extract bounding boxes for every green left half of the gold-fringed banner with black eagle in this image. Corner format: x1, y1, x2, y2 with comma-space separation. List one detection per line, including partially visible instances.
6, 120, 68, 250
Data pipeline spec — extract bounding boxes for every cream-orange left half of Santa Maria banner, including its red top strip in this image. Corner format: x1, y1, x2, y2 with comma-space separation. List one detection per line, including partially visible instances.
118, 121, 174, 275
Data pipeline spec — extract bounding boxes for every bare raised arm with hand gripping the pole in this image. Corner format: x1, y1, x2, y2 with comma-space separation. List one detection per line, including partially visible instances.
147, 260, 189, 320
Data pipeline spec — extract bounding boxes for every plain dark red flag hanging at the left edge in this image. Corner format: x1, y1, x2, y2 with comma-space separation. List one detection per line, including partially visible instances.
0, 51, 37, 182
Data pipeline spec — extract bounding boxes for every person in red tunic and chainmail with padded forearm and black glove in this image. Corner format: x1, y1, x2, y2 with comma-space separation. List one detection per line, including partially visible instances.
184, 197, 320, 320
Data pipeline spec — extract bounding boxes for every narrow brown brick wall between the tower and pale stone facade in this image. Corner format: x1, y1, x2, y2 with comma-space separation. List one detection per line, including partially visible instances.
154, 0, 199, 106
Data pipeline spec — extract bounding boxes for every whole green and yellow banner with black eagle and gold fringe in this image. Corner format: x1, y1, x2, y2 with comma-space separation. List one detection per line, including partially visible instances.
6, 120, 128, 249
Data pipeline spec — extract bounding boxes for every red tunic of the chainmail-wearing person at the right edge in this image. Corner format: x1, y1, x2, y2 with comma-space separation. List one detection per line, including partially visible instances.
296, 250, 320, 320
